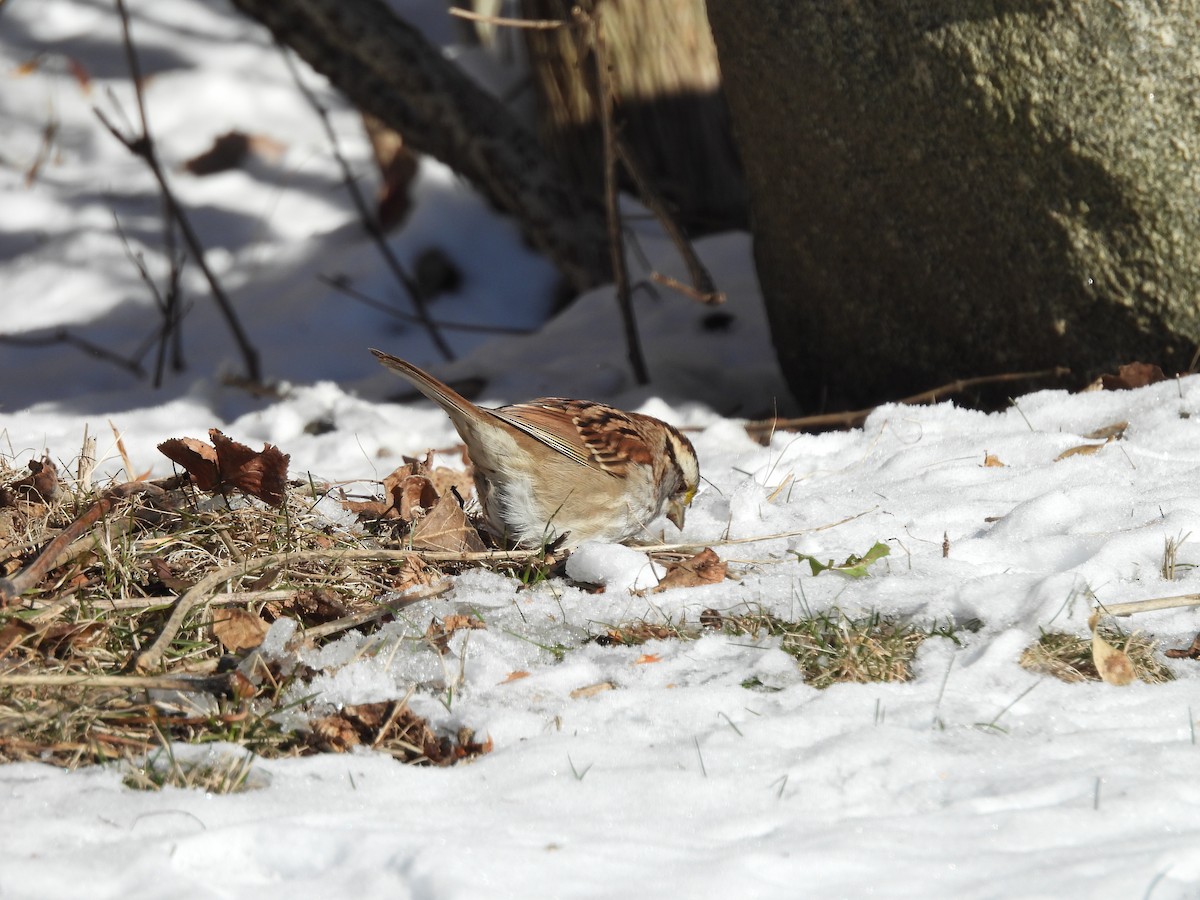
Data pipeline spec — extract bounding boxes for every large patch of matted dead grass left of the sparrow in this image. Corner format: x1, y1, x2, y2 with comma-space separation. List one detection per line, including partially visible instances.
0, 458, 516, 777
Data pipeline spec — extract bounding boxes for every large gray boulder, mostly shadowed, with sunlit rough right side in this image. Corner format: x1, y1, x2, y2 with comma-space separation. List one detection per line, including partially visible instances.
708, 0, 1200, 406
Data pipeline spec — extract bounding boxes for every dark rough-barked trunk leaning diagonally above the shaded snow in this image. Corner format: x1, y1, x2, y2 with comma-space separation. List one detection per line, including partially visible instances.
233, 0, 612, 290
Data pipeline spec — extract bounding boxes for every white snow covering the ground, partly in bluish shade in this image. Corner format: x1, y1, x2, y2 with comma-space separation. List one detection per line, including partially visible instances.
0, 0, 1200, 900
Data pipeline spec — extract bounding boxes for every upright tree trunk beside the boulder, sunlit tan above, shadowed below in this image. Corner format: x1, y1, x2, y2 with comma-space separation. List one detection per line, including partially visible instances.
521, 0, 748, 233
